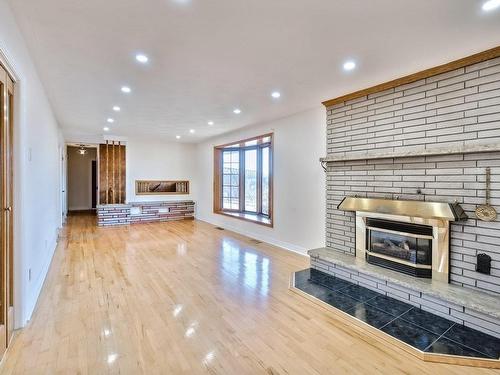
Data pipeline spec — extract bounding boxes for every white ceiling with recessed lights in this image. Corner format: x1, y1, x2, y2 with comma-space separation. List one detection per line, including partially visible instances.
9, 0, 500, 142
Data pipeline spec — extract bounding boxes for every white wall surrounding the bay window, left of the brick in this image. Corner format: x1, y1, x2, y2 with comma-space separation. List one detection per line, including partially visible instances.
195, 107, 326, 253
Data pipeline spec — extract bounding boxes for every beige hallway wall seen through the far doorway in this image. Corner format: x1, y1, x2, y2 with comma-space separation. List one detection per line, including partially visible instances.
68, 146, 97, 211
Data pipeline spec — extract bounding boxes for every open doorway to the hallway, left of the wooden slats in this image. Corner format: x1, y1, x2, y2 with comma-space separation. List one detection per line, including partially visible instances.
67, 145, 97, 214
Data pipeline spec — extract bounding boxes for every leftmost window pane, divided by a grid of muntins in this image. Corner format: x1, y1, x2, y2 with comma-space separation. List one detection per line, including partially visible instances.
222, 151, 240, 210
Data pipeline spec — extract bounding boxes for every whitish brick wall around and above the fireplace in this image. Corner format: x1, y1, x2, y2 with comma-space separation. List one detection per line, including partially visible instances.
326, 58, 500, 293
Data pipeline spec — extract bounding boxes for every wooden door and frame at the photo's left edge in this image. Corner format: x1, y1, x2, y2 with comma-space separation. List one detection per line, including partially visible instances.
0, 60, 14, 357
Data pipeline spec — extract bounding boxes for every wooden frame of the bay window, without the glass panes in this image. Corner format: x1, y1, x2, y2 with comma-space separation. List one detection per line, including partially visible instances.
213, 133, 274, 227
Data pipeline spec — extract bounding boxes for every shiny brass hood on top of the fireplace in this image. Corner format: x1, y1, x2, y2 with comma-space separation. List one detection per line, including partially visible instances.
338, 197, 468, 221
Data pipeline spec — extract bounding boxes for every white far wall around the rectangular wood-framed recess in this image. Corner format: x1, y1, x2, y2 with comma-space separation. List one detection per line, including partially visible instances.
126, 138, 197, 202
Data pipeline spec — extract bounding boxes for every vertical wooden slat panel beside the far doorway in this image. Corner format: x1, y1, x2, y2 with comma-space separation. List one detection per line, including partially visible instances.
99, 141, 126, 204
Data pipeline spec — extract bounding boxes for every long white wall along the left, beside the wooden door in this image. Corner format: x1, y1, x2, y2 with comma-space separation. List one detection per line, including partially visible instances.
0, 0, 62, 327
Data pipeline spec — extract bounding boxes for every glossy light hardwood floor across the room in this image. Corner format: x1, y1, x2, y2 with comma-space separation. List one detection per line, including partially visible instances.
0, 215, 498, 375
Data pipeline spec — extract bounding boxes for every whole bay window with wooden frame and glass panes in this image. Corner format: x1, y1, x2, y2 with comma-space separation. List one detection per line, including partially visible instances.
214, 134, 272, 226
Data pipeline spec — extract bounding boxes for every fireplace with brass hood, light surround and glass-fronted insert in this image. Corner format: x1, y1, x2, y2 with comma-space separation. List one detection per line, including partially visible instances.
338, 197, 467, 282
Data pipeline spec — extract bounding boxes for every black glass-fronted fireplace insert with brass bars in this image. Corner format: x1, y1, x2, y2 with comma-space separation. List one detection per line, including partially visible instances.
366, 217, 433, 278
